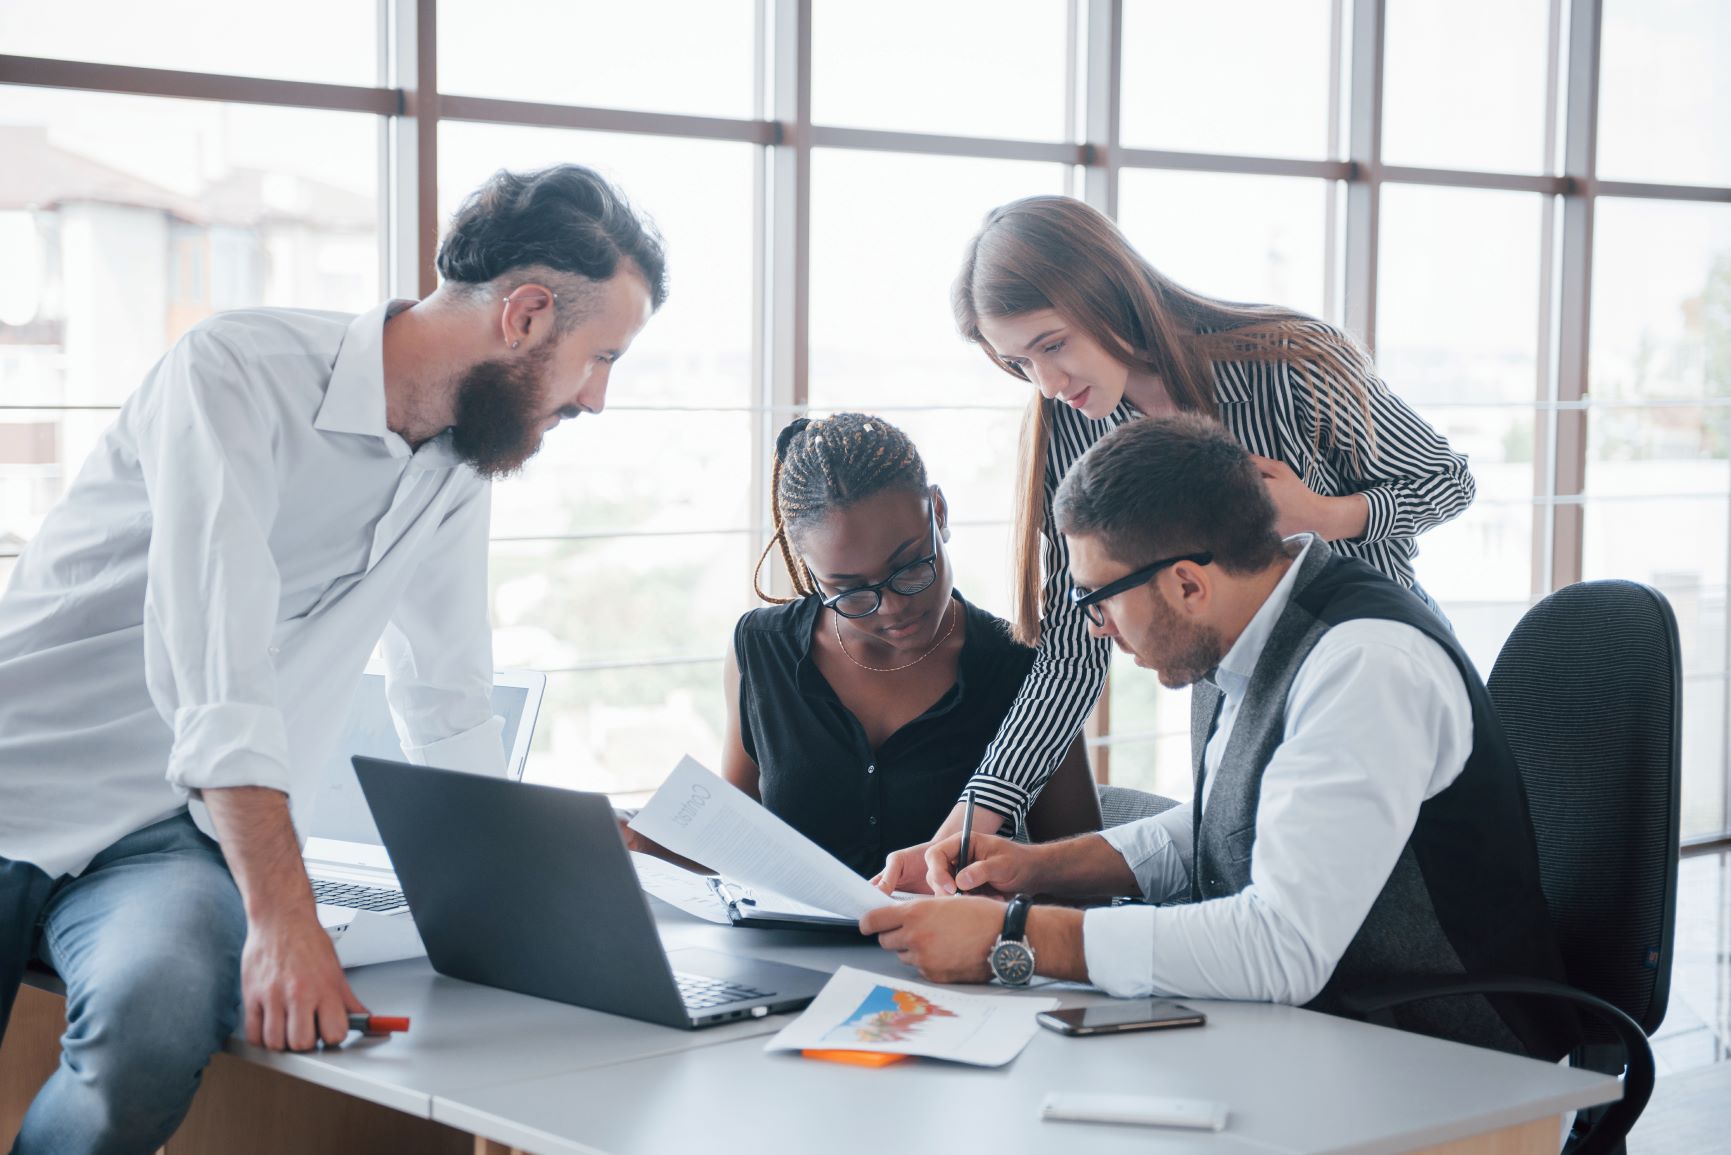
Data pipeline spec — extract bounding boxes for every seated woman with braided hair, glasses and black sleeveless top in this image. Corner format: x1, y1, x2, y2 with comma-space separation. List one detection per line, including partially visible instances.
685, 414, 1099, 876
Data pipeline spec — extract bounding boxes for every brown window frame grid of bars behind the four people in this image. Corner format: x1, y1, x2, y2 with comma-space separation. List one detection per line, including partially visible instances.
0, 0, 1731, 850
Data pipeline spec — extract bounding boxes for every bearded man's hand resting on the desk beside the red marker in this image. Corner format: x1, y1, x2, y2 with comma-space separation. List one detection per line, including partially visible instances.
241, 913, 367, 1051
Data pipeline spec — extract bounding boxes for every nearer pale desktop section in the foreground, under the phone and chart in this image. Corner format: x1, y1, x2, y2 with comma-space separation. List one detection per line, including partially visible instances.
433, 1003, 1615, 1155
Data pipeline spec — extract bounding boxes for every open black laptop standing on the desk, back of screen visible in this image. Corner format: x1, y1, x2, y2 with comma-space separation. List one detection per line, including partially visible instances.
355, 757, 829, 1029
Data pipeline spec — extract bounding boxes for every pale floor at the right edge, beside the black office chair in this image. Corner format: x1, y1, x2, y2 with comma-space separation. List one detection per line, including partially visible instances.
1629, 854, 1731, 1155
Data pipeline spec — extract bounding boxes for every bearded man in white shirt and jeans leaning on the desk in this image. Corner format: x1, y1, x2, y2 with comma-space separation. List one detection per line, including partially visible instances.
0, 165, 666, 1155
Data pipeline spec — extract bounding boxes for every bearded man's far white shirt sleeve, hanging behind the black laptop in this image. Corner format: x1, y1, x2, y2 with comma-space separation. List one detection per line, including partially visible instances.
383, 485, 505, 776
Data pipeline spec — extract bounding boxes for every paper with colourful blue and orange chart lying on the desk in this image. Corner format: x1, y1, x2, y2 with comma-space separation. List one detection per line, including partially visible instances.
763, 966, 1058, 1067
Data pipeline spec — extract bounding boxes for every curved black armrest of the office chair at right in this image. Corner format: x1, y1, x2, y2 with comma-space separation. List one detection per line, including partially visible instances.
1340, 975, 1655, 1155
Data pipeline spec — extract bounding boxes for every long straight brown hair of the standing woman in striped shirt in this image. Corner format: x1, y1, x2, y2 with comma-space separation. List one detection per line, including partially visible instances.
950, 196, 1374, 646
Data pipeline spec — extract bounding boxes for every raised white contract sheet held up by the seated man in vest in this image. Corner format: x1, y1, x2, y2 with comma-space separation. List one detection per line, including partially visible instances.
630, 758, 891, 918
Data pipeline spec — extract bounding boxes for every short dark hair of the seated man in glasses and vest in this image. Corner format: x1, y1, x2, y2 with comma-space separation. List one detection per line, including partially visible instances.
1052, 414, 1281, 573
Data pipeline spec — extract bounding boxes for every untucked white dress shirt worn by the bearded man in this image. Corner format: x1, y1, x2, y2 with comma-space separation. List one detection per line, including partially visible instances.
0, 301, 504, 876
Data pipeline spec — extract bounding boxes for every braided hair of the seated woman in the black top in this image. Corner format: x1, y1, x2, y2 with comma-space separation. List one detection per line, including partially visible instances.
751, 414, 926, 604
